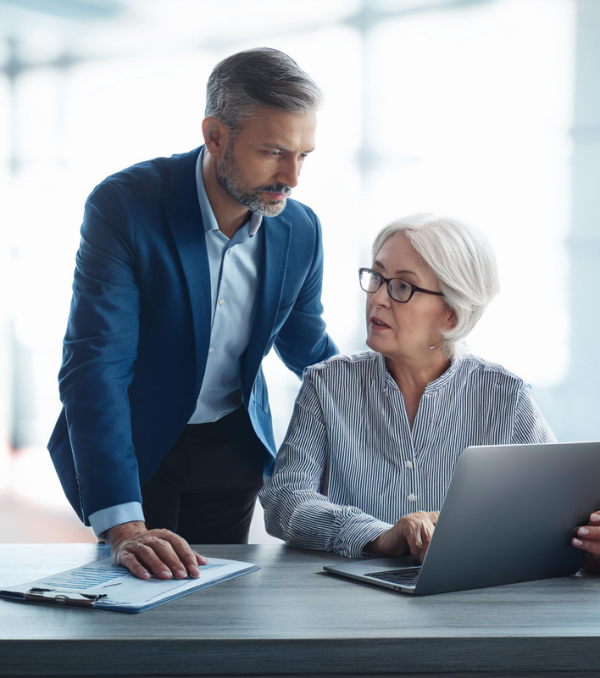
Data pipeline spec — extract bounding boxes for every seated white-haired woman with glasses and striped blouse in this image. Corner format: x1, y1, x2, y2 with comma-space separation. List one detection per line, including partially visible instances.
259, 214, 556, 558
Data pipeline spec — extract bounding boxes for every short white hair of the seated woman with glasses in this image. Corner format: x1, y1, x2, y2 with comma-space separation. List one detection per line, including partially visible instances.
373, 214, 500, 358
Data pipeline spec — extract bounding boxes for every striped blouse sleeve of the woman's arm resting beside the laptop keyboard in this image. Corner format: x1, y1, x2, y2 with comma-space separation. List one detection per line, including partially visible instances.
259, 371, 391, 558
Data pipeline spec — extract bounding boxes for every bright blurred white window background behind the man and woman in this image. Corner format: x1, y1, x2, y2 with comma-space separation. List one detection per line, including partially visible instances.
0, 0, 600, 542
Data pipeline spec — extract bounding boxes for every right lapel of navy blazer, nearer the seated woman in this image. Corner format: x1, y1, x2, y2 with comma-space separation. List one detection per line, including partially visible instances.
242, 216, 292, 405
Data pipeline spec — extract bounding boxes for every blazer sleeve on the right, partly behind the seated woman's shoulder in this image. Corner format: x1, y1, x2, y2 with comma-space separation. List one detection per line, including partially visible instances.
274, 214, 339, 378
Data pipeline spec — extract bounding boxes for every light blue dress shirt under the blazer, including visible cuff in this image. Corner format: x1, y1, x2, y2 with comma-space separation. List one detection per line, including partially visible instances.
89, 149, 264, 536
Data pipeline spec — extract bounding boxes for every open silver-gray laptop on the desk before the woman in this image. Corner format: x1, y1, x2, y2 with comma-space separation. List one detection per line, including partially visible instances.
324, 442, 600, 595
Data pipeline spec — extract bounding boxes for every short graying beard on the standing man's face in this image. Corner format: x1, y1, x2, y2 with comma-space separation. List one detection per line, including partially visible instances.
217, 141, 292, 217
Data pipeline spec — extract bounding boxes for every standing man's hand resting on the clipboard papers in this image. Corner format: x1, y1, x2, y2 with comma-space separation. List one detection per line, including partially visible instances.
105, 521, 206, 579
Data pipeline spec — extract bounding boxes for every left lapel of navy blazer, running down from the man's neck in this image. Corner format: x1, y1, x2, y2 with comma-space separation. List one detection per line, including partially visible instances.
163, 148, 211, 388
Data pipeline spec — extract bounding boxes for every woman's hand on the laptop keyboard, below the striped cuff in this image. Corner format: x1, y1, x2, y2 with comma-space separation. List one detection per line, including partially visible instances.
365, 511, 440, 562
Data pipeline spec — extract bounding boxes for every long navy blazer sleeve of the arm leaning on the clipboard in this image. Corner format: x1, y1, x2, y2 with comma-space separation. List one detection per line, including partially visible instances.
59, 182, 141, 521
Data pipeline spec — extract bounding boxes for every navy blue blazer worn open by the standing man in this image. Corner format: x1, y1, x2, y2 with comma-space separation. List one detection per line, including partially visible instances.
48, 149, 337, 525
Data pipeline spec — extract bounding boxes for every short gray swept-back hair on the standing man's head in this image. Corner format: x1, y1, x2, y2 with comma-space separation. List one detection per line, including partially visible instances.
205, 47, 321, 135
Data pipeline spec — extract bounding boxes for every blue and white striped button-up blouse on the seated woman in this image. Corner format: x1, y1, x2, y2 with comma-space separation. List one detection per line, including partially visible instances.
259, 351, 556, 558
